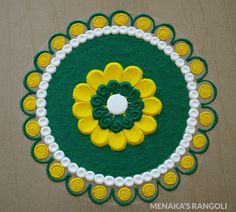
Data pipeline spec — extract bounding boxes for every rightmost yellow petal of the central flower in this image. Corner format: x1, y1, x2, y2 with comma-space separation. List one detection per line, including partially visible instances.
142, 97, 162, 116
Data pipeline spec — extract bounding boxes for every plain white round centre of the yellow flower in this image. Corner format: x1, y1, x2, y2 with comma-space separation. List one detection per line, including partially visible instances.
107, 94, 128, 115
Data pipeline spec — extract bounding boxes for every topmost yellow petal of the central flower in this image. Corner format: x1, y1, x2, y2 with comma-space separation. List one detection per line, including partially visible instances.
104, 62, 123, 82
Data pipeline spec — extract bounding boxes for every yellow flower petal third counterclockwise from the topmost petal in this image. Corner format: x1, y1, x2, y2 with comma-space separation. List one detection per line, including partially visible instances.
72, 102, 92, 119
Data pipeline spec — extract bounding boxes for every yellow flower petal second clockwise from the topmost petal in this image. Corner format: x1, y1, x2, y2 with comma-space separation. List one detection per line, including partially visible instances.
135, 79, 157, 98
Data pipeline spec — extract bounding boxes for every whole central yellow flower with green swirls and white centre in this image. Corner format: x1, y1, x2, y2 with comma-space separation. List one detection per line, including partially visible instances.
72, 62, 162, 151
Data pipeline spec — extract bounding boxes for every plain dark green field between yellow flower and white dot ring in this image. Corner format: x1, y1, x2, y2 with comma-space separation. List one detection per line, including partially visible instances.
46, 35, 189, 177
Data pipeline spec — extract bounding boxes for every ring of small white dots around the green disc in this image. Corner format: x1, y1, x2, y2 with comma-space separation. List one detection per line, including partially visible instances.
36, 26, 200, 187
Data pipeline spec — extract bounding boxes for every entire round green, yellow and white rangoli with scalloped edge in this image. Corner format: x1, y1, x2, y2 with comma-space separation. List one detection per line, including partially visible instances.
21, 10, 218, 206
